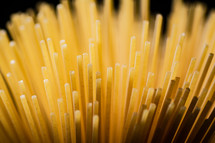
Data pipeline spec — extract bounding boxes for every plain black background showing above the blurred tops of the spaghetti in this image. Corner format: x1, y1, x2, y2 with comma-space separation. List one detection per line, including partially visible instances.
0, 0, 215, 29
